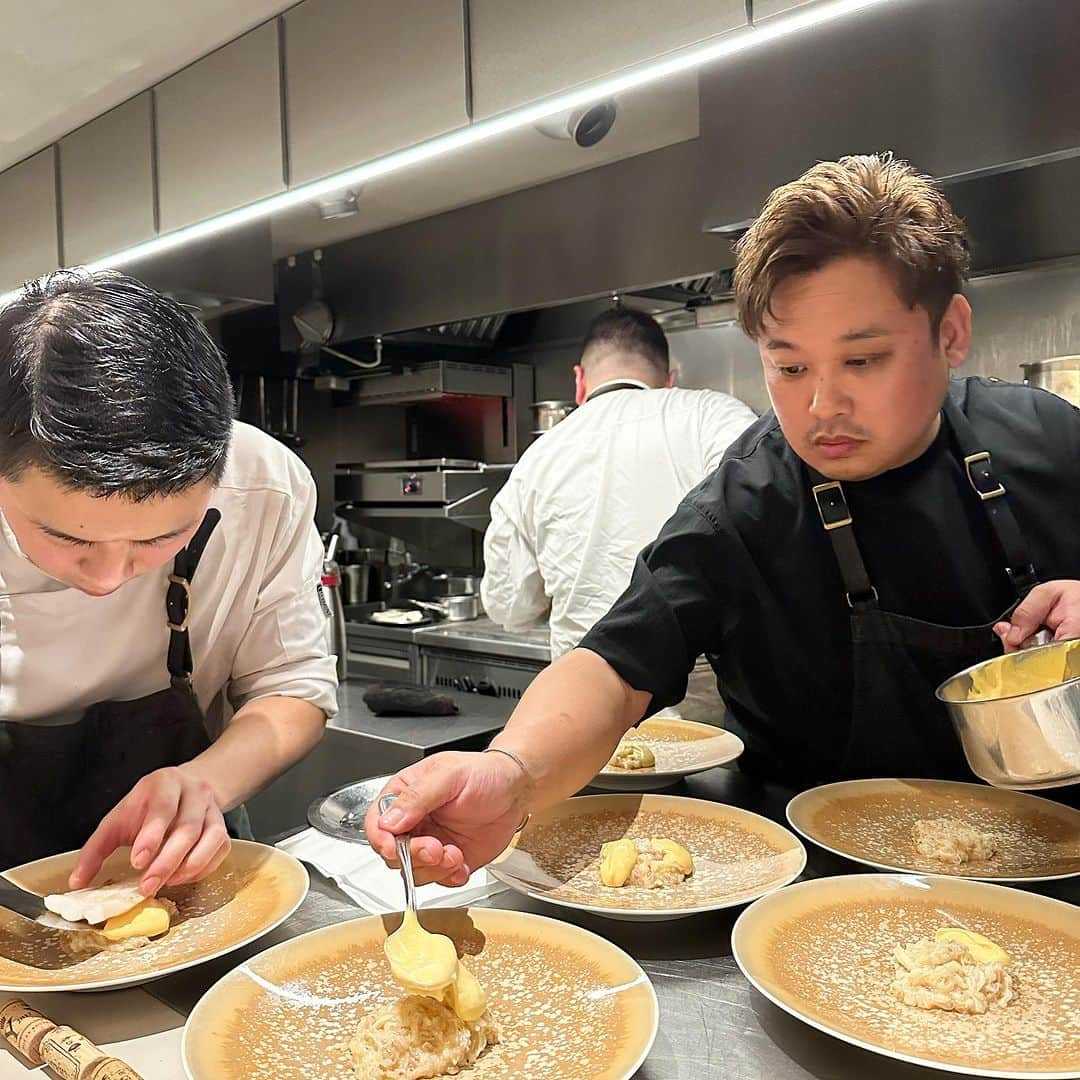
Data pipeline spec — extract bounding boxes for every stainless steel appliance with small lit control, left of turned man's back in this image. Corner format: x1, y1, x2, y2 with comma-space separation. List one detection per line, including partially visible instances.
334, 458, 513, 532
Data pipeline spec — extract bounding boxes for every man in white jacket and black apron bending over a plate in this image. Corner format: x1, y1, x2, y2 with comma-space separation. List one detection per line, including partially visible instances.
0, 271, 336, 895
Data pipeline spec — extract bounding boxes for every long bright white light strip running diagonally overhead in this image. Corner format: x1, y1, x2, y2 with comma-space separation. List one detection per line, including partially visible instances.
0, 0, 885, 308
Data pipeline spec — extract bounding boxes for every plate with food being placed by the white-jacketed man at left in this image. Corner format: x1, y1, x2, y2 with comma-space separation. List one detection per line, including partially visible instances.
0, 840, 308, 991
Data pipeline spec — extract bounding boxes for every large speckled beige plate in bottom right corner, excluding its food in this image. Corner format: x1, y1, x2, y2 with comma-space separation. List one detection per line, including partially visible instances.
731, 874, 1080, 1080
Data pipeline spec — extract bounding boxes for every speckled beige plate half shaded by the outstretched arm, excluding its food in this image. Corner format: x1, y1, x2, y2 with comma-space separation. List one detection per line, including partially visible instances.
488, 795, 807, 920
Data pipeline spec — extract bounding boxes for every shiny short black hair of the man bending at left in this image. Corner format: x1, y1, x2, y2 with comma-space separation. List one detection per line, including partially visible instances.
0, 270, 233, 501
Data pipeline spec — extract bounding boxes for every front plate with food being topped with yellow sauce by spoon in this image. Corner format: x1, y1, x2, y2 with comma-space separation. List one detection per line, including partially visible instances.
183, 908, 659, 1080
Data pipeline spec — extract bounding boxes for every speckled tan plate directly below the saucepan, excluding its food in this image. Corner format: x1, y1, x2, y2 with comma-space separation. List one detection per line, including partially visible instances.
787, 780, 1080, 881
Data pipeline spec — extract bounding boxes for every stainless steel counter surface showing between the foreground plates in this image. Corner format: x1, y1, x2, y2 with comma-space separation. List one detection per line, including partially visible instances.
147, 769, 1080, 1080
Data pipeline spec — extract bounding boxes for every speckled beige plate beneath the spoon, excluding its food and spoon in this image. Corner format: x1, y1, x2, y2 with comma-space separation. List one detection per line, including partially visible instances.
184, 908, 659, 1080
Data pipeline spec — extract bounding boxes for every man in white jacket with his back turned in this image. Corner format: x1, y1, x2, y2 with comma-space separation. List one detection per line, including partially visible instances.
482, 307, 756, 724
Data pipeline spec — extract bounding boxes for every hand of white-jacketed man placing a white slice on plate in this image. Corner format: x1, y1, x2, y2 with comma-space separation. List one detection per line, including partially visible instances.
68, 765, 230, 896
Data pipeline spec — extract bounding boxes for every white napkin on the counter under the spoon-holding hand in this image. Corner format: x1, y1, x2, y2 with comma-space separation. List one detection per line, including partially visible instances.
278, 828, 507, 915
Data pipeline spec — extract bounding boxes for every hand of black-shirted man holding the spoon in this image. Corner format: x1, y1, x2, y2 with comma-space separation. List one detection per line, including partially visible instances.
365, 752, 530, 886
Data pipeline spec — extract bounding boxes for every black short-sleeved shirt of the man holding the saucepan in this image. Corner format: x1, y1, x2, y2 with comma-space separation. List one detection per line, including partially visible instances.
581, 378, 1080, 783
